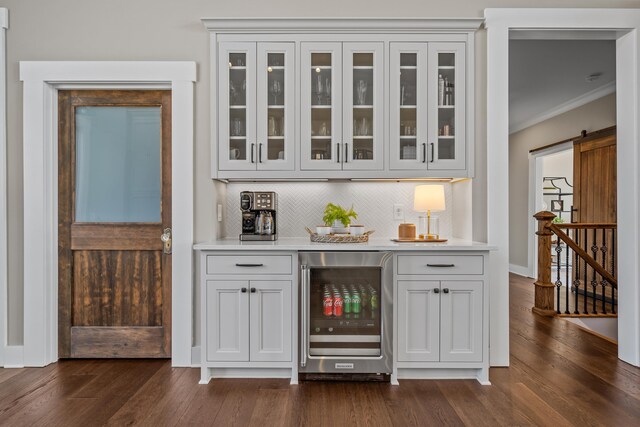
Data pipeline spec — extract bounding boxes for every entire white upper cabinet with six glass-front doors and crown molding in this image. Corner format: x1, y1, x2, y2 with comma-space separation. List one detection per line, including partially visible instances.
203, 18, 482, 180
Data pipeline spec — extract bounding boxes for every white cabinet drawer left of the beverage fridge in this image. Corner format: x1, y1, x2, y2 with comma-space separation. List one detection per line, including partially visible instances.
207, 255, 292, 275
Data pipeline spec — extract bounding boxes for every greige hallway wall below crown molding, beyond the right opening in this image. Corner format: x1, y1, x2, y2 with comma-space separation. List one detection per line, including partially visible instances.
509, 93, 616, 268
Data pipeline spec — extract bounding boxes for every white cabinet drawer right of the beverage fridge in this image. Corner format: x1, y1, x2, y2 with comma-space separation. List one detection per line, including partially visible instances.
398, 255, 484, 274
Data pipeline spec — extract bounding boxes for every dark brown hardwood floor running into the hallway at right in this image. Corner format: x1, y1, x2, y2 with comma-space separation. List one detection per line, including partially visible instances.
0, 276, 640, 427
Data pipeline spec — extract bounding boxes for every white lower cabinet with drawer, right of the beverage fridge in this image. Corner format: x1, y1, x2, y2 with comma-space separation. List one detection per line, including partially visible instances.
395, 252, 489, 384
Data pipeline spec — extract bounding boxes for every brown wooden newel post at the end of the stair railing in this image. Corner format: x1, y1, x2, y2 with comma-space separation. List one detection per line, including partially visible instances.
533, 211, 556, 316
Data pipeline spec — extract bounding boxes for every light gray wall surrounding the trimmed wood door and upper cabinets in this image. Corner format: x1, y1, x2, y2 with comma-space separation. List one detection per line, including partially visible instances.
2, 0, 638, 344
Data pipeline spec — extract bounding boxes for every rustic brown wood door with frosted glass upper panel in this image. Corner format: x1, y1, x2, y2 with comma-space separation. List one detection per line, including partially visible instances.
58, 90, 171, 358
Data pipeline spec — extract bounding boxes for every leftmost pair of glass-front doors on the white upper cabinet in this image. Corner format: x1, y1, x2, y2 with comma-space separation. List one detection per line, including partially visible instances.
218, 42, 295, 171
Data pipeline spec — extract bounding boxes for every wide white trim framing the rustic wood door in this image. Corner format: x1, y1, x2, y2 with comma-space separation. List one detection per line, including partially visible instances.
20, 61, 196, 366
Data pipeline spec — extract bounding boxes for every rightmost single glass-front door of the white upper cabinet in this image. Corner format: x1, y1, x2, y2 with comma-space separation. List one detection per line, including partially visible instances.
428, 43, 466, 170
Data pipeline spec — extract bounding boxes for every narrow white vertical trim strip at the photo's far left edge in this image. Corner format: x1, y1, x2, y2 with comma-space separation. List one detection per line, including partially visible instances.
0, 8, 9, 368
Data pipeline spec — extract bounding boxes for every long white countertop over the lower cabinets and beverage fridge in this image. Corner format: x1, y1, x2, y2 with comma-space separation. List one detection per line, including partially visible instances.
193, 236, 497, 251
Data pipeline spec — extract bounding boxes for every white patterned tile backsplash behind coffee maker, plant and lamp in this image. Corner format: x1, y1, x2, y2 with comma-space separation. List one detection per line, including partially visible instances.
223, 182, 453, 238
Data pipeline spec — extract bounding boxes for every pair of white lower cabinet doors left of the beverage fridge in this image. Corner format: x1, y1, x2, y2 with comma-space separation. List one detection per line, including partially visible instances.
207, 280, 292, 362
